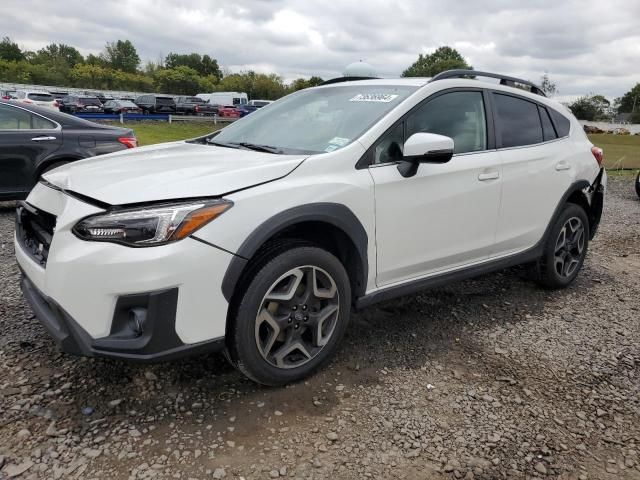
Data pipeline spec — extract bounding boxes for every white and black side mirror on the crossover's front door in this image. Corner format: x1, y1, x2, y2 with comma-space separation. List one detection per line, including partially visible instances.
398, 133, 454, 178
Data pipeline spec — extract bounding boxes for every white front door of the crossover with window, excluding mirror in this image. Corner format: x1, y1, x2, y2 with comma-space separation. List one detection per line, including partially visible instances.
369, 89, 501, 287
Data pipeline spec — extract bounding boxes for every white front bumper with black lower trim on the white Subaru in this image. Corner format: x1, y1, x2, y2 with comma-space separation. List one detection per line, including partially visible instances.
15, 183, 233, 360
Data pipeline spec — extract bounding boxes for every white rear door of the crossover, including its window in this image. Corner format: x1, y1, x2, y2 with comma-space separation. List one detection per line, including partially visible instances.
492, 92, 575, 256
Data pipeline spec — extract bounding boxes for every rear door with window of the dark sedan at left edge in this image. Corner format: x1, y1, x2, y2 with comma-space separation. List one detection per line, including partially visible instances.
0, 104, 62, 198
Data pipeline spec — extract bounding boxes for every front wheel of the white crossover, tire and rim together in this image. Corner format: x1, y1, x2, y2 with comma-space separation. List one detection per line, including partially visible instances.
227, 242, 351, 386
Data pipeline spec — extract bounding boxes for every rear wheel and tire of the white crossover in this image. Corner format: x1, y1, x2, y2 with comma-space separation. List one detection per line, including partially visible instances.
535, 203, 589, 289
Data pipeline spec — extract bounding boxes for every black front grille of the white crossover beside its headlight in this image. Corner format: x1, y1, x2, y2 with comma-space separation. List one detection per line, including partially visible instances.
16, 202, 56, 267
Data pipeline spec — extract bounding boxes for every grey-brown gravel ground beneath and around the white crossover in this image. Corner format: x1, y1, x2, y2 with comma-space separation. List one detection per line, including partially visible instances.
0, 176, 640, 479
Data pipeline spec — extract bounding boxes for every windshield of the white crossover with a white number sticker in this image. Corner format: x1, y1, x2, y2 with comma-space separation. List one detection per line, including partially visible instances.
212, 85, 417, 154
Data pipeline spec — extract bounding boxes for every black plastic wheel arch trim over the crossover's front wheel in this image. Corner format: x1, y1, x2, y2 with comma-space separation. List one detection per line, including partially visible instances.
222, 203, 369, 302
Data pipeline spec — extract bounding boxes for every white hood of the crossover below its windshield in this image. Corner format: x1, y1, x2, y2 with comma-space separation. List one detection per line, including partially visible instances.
44, 142, 307, 205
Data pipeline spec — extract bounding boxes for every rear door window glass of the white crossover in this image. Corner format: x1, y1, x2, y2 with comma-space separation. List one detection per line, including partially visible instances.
493, 93, 543, 148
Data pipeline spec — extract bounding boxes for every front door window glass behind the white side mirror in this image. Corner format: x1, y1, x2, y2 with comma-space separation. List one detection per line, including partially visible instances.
406, 92, 487, 153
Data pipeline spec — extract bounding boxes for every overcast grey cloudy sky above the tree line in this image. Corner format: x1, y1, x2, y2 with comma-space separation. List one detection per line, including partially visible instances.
0, 0, 640, 98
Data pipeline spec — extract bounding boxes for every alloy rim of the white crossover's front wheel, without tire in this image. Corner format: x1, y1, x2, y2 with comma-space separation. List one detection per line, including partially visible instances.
255, 265, 340, 369
